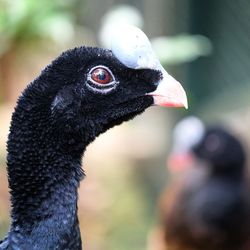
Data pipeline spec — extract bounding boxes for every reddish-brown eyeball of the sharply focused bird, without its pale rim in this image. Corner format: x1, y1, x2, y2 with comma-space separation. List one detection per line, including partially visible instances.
90, 67, 114, 84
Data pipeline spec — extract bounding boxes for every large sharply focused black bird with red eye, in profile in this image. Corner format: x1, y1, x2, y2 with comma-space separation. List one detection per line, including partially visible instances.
0, 27, 186, 250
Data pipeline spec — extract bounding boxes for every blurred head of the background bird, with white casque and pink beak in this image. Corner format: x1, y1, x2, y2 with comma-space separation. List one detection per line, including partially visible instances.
168, 116, 246, 172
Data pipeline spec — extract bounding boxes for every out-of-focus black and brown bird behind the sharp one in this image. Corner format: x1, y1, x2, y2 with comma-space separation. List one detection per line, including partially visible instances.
161, 118, 249, 250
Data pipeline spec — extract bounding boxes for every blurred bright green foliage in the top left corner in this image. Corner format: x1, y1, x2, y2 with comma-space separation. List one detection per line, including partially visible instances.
0, 0, 75, 55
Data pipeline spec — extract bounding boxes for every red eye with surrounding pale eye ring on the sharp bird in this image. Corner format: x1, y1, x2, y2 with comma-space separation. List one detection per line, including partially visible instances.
87, 65, 119, 94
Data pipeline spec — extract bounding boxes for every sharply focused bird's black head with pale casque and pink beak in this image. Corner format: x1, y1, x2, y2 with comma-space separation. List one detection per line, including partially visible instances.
21, 27, 187, 148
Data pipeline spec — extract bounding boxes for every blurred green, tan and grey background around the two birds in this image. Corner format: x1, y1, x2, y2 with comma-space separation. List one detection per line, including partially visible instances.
0, 0, 250, 250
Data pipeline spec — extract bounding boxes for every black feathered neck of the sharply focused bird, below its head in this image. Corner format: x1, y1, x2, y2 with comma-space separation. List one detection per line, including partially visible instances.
7, 100, 86, 249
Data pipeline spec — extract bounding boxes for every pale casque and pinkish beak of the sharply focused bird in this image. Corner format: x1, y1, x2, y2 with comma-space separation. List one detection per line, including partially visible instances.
111, 25, 188, 108
